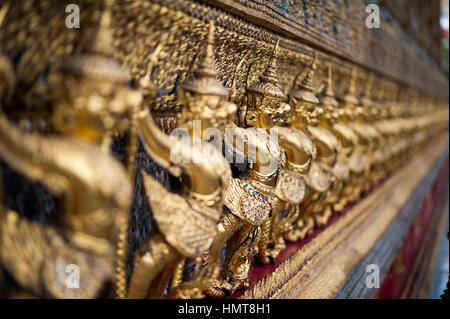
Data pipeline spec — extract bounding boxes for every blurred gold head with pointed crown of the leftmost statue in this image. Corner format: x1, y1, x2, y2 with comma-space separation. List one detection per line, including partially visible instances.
49, 0, 142, 141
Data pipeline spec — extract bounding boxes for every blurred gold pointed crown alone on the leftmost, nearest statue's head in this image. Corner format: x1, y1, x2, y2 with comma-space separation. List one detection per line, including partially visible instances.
61, 0, 129, 83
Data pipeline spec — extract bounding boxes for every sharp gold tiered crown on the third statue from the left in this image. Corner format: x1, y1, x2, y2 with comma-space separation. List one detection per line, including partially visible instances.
248, 40, 286, 101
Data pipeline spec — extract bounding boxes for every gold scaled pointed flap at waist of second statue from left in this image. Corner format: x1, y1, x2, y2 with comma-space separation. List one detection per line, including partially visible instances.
142, 171, 220, 257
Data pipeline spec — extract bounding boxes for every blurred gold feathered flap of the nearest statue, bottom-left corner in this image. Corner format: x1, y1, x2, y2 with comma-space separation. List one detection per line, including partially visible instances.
0, 211, 113, 299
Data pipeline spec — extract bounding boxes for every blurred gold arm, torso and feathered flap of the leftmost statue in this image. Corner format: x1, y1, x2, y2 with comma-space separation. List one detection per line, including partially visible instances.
0, 114, 131, 298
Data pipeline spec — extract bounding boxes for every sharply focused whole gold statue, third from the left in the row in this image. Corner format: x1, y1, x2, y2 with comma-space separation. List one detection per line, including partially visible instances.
208, 37, 290, 297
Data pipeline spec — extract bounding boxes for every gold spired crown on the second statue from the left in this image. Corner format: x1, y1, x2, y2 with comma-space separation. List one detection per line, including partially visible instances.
180, 21, 230, 98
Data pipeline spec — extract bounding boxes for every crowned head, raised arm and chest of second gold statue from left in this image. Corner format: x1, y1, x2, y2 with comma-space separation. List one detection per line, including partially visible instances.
137, 22, 229, 200
